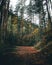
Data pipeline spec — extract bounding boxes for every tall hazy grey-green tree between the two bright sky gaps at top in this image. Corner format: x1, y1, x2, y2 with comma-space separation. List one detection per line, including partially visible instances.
15, 0, 26, 36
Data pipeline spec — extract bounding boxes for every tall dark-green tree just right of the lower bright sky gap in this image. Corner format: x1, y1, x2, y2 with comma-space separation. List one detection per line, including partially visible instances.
32, 0, 46, 40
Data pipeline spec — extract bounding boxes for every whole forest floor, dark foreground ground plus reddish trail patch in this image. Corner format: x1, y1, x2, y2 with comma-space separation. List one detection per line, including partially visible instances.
0, 46, 52, 65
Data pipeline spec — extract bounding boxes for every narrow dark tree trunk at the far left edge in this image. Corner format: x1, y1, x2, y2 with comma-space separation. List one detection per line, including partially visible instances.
0, 0, 6, 43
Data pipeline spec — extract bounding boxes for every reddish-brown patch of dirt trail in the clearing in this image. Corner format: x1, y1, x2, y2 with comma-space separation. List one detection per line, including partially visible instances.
13, 46, 38, 55
